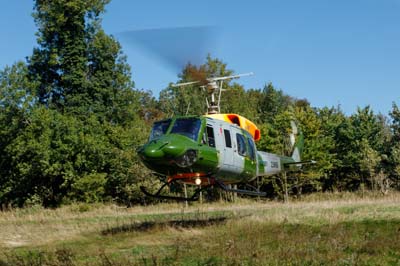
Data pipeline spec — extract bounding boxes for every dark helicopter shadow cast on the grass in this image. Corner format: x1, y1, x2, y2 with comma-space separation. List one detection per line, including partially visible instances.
101, 217, 228, 235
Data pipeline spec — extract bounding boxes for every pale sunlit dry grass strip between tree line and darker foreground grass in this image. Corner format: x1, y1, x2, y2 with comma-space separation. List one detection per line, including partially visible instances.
0, 193, 400, 247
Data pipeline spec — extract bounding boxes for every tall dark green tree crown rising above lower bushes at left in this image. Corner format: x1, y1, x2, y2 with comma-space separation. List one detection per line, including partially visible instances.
28, 0, 133, 123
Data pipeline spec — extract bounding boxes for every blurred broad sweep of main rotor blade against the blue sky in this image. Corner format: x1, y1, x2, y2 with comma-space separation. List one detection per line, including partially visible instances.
117, 26, 217, 72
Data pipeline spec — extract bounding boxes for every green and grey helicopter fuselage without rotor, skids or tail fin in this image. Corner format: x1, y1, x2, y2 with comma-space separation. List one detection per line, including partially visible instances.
138, 116, 304, 184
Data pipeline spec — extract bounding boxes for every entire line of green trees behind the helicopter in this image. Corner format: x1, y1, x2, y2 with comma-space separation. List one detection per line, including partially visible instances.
0, 0, 400, 207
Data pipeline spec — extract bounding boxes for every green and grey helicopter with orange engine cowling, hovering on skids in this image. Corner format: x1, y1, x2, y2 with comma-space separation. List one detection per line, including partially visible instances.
137, 72, 315, 201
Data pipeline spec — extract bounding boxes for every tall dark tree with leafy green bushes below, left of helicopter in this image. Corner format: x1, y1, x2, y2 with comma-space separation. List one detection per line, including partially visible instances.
0, 0, 153, 206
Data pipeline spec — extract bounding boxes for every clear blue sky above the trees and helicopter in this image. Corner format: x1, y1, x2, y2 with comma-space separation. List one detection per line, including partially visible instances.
0, 0, 400, 114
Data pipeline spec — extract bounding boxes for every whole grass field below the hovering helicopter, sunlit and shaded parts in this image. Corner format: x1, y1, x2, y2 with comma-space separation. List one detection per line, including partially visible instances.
0, 193, 400, 265
